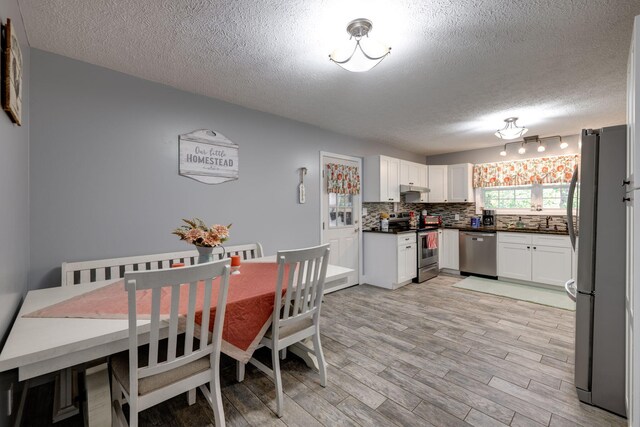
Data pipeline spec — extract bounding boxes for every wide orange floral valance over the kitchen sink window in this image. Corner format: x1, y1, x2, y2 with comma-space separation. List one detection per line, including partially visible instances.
473, 154, 580, 188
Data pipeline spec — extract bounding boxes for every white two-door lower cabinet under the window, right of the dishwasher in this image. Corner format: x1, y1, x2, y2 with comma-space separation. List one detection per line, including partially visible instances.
498, 232, 573, 286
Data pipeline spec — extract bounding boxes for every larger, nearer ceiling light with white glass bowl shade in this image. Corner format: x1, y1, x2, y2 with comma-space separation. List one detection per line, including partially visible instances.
329, 18, 391, 73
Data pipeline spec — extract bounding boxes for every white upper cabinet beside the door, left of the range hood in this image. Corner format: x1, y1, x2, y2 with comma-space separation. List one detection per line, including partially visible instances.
363, 156, 400, 202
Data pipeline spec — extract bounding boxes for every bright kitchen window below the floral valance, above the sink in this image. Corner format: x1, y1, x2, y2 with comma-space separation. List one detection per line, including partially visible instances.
476, 184, 577, 213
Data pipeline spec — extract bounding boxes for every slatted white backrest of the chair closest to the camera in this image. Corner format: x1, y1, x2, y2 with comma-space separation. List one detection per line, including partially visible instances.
125, 260, 230, 393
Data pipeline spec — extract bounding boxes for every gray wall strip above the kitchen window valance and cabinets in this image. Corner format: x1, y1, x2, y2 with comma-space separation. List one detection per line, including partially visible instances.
427, 135, 580, 165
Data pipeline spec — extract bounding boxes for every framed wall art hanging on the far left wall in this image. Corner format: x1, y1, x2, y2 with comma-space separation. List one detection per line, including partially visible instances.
2, 18, 22, 125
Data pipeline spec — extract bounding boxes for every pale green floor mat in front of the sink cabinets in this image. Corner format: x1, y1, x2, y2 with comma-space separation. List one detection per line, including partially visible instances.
453, 276, 576, 311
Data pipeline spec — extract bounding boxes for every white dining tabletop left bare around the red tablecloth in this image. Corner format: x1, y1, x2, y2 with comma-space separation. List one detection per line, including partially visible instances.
0, 256, 352, 381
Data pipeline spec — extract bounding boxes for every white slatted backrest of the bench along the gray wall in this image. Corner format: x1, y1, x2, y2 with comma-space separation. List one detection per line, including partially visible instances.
62, 243, 263, 286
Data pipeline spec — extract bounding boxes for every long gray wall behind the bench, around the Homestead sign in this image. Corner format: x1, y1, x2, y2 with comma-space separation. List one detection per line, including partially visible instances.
29, 49, 424, 288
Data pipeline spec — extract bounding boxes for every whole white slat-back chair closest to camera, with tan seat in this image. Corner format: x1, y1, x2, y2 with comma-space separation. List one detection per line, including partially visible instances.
111, 260, 230, 427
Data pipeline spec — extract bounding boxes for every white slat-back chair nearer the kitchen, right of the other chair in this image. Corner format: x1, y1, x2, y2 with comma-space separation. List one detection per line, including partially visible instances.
238, 244, 329, 417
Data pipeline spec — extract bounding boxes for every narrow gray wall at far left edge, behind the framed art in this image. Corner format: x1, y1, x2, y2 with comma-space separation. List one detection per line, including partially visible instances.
0, 0, 30, 426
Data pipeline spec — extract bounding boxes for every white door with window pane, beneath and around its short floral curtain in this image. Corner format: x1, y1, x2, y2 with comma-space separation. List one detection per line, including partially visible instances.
321, 154, 362, 286
